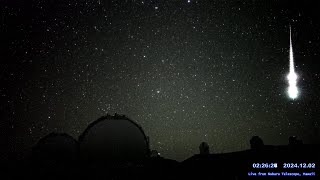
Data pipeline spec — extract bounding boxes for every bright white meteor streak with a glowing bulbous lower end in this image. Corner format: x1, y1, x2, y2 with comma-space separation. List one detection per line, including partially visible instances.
287, 26, 299, 99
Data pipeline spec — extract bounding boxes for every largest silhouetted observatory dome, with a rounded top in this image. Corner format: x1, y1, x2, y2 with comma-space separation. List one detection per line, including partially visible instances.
79, 114, 150, 165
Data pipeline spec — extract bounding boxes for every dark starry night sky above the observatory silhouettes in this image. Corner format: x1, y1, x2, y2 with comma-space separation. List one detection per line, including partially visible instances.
0, 0, 320, 160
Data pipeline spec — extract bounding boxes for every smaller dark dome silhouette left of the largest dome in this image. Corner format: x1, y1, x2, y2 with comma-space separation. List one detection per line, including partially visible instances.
30, 133, 79, 179
